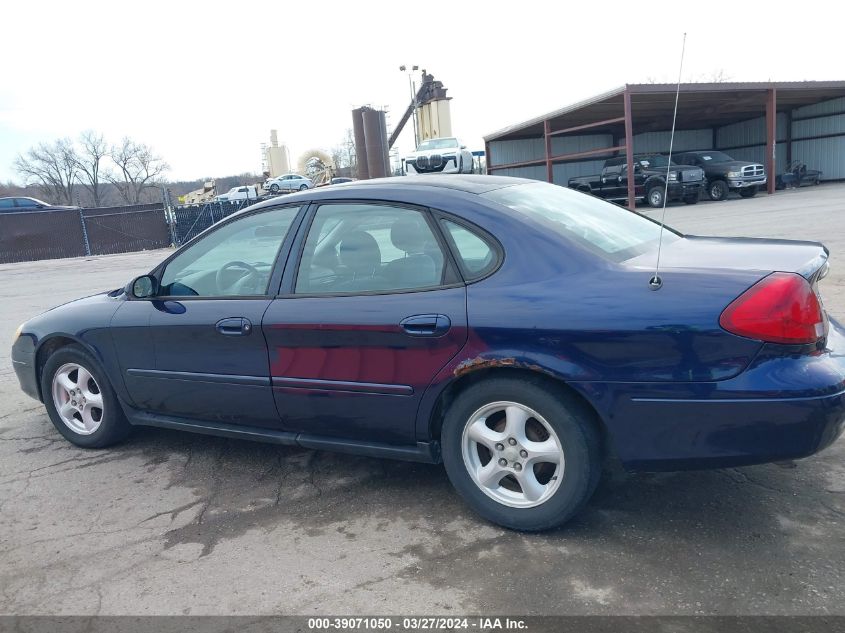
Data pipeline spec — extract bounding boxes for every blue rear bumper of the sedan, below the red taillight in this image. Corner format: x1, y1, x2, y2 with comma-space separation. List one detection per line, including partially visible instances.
573, 319, 845, 470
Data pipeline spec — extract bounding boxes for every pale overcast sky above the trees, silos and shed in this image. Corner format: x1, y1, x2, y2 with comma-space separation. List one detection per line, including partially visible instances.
0, 0, 845, 181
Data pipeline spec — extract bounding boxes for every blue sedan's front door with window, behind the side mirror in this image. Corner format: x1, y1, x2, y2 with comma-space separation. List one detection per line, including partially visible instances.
112, 206, 300, 427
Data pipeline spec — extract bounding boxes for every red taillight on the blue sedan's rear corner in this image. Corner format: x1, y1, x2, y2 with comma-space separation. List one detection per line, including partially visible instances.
719, 273, 824, 345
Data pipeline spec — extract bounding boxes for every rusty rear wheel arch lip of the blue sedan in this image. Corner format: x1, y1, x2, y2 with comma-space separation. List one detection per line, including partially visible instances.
427, 361, 615, 457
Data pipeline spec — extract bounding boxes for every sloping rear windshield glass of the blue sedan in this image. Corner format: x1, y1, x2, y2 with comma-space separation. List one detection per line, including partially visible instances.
481, 182, 680, 262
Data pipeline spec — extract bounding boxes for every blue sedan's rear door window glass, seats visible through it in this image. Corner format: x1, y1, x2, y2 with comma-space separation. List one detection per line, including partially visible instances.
296, 204, 445, 294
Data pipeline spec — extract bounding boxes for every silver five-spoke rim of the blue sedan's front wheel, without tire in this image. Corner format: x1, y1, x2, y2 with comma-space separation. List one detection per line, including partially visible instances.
53, 363, 105, 435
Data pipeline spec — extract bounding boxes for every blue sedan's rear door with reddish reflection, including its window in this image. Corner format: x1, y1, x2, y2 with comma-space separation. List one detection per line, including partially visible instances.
263, 202, 467, 444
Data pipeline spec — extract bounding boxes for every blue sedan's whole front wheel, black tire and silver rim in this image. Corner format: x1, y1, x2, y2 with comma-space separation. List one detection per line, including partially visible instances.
41, 345, 132, 448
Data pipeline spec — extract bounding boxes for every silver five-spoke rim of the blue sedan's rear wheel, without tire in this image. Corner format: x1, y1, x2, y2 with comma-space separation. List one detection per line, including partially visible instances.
461, 401, 565, 508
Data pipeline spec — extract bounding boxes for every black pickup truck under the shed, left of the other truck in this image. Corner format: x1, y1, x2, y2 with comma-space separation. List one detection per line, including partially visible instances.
569, 154, 705, 207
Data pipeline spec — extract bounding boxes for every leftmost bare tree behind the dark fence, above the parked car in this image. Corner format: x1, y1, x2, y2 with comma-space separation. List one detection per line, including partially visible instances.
14, 138, 78, 204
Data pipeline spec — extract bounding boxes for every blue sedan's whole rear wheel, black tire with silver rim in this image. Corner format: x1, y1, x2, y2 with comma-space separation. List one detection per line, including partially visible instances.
441, 378, 602, 532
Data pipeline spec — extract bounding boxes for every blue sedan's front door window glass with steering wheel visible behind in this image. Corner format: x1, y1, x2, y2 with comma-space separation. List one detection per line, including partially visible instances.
159, 207, 299, 297
